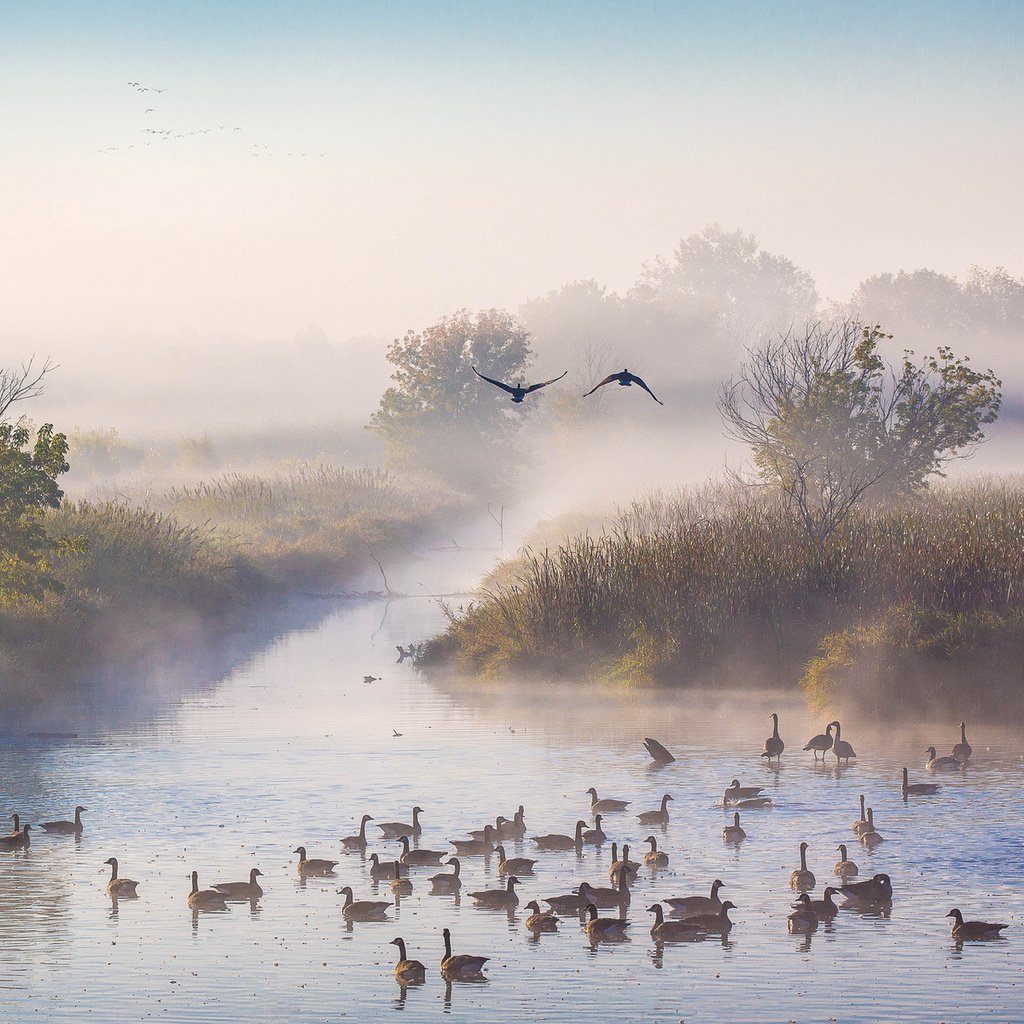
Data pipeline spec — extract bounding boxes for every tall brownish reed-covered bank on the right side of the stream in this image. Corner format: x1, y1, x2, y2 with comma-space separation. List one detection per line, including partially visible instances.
432, 480, 1024, 711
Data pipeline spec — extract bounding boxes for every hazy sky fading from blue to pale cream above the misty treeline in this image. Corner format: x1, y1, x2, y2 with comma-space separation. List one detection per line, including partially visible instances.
0, 0, 1024, 352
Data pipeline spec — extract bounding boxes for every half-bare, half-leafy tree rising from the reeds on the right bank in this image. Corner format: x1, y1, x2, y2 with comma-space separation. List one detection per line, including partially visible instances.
719, 321, 1001, 543
